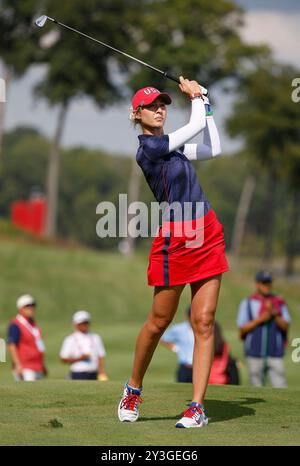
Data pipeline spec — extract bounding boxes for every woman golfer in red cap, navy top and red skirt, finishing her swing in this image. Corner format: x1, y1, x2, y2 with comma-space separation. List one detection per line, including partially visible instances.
118, 77, 228, 428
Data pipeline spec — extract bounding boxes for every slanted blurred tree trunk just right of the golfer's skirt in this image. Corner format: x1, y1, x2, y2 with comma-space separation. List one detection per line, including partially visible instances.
231, 175, 256, 260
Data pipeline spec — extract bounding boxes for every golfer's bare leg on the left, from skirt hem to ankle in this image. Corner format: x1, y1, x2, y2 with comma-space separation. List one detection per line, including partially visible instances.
128, 285, 185, 388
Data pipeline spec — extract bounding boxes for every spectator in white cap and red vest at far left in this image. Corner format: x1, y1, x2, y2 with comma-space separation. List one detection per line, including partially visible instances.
7, 294, 47, 382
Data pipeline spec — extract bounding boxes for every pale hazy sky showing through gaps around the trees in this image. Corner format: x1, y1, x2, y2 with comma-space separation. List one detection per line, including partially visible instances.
5, 0, 300, 155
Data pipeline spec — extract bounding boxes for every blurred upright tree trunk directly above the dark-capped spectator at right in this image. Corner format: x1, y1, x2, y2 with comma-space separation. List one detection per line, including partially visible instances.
262, 166, 278, 269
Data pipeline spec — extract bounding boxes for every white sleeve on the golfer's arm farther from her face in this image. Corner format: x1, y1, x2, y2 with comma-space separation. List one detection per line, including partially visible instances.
183, 116, 221, 160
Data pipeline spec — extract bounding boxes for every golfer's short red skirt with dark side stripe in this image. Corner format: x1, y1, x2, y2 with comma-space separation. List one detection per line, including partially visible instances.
148, 209, 229, 286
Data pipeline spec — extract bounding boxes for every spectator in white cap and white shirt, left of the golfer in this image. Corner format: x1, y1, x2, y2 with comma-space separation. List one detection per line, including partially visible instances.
60, 311, 108, 382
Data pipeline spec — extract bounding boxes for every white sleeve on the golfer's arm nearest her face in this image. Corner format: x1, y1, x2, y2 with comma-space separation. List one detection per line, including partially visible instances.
169, 99, 206, 152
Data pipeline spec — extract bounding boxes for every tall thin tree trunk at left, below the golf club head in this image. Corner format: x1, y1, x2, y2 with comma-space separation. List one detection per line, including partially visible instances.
45, 104, 68, 238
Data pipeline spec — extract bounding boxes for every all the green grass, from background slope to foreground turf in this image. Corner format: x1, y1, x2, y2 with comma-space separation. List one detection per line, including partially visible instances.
0, 235, 300, 445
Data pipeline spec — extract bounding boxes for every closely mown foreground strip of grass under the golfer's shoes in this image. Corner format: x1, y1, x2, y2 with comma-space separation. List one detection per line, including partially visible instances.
0, 381, 300, 446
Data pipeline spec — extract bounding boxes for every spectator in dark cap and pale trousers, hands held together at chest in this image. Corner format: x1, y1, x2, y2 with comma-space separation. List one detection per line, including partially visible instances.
237, 270, 291, 388
